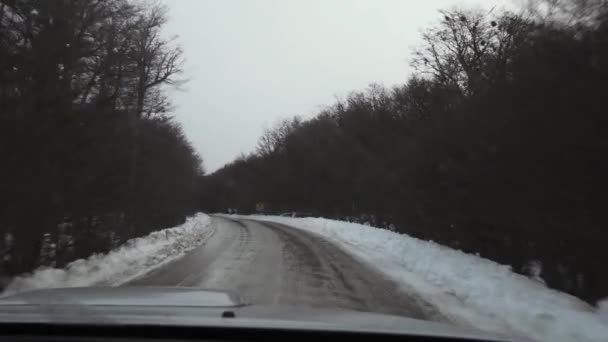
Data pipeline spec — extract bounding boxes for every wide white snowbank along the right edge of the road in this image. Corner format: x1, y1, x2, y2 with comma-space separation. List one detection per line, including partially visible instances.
241, 216, 608, 341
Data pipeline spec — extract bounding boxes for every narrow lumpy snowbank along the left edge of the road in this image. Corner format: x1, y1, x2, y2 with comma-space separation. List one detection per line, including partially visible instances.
2, 214, 213, 295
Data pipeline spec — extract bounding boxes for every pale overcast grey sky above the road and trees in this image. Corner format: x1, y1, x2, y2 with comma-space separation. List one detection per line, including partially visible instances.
165, 0, 510, 172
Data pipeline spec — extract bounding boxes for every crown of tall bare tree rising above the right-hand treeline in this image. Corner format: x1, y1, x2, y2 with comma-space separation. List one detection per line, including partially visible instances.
411, 10, 528, 97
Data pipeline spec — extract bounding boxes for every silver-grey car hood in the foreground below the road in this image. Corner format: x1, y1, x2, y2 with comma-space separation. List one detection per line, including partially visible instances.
0, 287, 512, 341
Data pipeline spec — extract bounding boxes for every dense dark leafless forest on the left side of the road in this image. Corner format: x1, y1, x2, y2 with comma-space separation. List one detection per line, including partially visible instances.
0, 0, 203, 281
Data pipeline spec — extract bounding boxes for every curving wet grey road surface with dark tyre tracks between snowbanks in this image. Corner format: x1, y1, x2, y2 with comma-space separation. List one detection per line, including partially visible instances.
127, 216, 437, 319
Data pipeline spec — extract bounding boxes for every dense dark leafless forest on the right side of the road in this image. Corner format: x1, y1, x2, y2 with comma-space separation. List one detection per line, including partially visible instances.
200, 0, 608, 302
